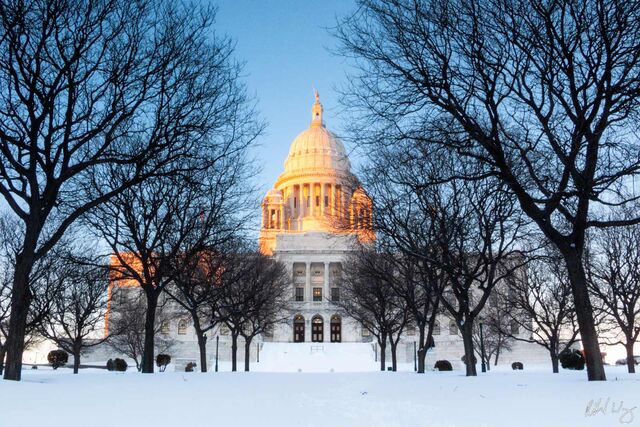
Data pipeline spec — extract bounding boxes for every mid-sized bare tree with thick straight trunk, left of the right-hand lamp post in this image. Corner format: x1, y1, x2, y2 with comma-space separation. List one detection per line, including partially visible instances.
422, 179, 523, 376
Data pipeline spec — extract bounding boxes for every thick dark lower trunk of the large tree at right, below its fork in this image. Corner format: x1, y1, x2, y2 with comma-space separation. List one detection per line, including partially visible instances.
563, 249, 607, 381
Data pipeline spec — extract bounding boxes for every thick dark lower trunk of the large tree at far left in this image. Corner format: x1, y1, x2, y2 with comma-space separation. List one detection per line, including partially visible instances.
4, 249, 37, 381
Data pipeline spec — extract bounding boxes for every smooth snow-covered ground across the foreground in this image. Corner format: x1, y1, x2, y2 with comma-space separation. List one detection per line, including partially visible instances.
0, 366, 640, 427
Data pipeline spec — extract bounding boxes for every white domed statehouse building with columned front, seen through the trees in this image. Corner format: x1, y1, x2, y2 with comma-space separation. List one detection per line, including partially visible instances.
93, 93, 548, 367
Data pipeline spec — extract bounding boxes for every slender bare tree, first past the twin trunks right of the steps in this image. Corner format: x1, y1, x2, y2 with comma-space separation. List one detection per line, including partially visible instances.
363, 139, 460, 373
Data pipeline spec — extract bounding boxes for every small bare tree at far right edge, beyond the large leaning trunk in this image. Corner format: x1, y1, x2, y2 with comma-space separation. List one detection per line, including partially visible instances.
588, 225, 640, 373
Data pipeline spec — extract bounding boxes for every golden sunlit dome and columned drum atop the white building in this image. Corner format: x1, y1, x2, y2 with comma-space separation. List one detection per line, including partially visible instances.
259, 91, 374, 254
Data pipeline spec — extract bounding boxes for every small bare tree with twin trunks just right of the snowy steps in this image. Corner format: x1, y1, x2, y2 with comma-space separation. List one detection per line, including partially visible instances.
335, 246, 409, 371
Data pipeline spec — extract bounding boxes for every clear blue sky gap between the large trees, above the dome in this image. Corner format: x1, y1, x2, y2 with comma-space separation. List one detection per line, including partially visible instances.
212, 0, 355, 196
